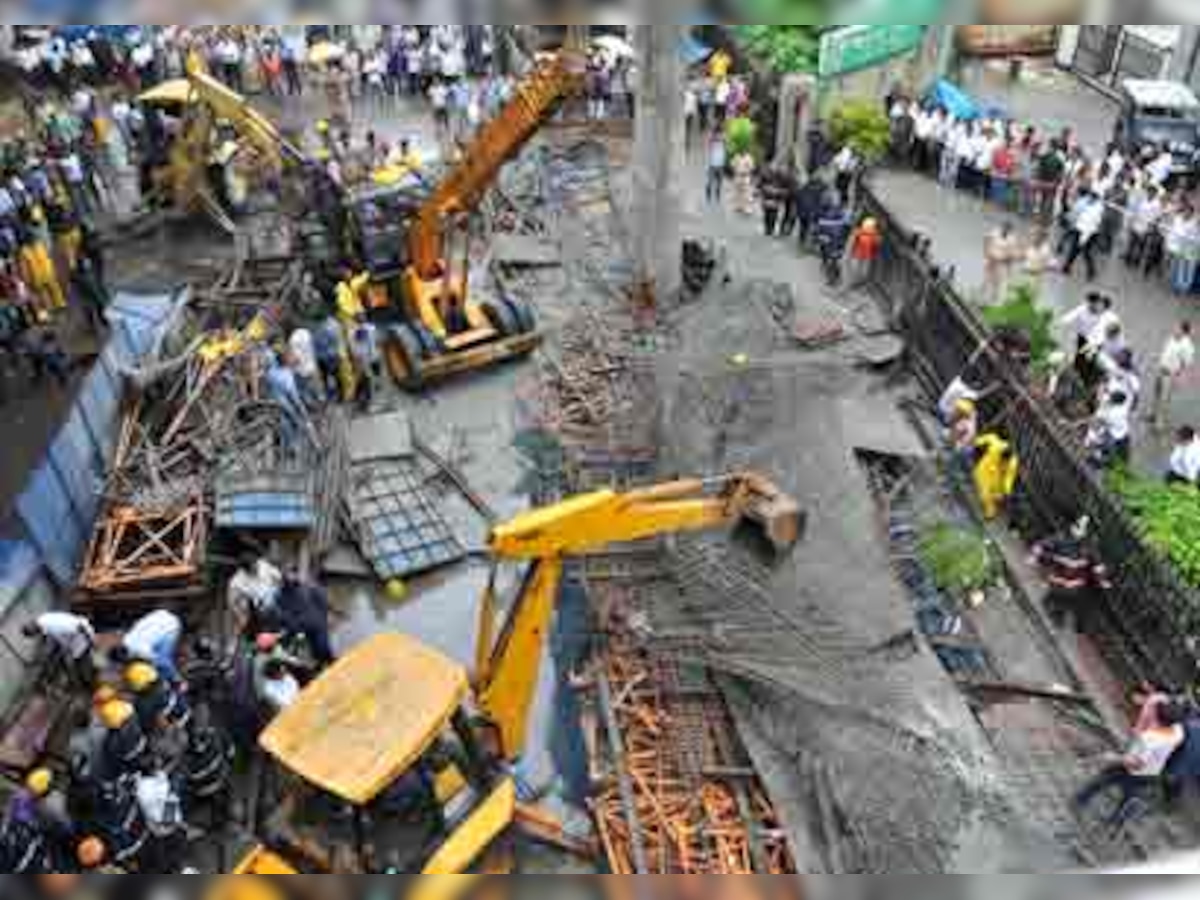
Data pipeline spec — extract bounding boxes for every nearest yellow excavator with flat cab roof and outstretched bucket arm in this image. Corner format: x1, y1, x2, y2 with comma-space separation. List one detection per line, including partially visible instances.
233, 474, 804, 895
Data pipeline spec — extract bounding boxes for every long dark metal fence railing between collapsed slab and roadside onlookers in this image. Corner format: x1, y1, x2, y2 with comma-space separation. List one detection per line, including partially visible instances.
860, 184, 1200, 688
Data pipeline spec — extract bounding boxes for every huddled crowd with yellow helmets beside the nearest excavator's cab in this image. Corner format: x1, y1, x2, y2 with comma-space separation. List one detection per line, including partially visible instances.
0, 553, 334, 875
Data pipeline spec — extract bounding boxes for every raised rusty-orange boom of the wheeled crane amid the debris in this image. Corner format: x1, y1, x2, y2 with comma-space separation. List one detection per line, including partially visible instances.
409, 52, 582, 281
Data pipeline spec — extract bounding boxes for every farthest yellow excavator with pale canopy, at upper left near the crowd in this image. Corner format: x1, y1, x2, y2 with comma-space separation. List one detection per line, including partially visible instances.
138, 70, 306, 233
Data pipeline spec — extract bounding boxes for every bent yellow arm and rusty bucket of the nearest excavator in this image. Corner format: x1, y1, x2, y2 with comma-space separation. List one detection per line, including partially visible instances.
475, 474, 804, 758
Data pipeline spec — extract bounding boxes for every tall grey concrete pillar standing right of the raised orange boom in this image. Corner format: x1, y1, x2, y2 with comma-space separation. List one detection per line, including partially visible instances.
634, 24, 686, 304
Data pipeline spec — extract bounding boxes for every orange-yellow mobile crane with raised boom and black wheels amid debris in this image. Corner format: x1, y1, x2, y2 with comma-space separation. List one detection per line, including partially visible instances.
346, 50, 586, 390
